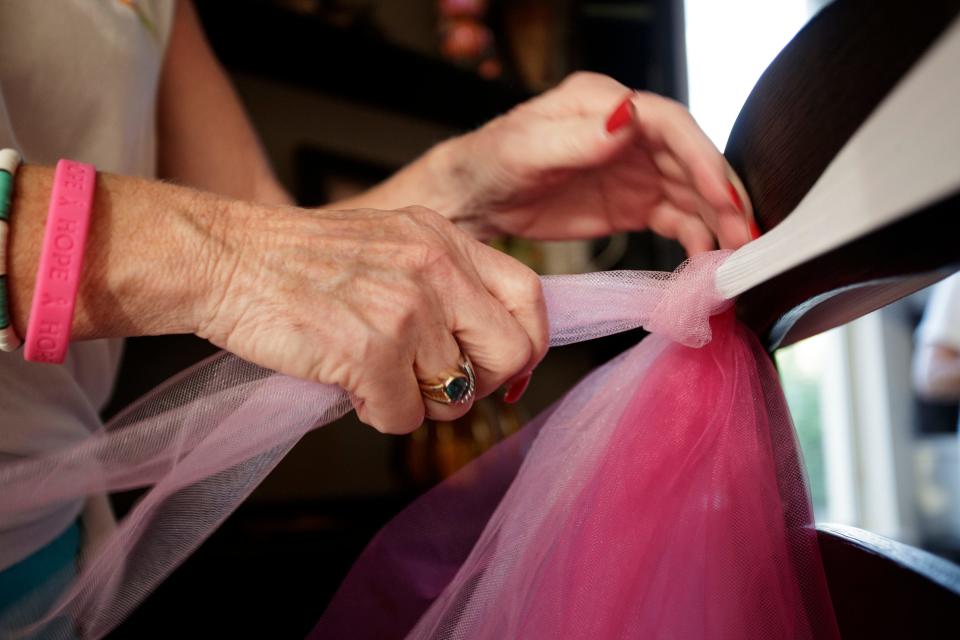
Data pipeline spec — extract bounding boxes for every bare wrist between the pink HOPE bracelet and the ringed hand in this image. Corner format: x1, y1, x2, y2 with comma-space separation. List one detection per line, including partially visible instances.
75, 174, 230, 338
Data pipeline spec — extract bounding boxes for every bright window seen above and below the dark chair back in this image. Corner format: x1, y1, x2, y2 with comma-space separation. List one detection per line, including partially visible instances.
684, 0, 872, 533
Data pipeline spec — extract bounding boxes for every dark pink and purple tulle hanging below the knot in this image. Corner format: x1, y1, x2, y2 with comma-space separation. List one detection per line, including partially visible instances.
312, 312, 839, 639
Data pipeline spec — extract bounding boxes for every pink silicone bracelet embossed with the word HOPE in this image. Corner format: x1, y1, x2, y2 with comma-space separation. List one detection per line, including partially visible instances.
23, 160, 97, 364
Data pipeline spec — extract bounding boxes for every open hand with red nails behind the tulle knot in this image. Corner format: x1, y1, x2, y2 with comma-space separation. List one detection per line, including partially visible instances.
442, 73, 755, 254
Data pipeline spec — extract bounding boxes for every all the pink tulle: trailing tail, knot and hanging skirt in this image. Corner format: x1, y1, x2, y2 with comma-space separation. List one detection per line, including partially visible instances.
0, 252, 837, 638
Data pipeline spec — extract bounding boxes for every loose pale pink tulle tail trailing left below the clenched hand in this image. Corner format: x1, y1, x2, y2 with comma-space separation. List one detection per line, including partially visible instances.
0, 353, 350, 639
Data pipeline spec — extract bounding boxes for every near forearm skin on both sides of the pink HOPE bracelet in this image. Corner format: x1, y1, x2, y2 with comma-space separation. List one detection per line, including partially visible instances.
8, 165, 231, 340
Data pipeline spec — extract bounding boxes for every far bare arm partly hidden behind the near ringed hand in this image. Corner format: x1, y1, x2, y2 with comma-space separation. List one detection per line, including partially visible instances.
157, 2, 490, 226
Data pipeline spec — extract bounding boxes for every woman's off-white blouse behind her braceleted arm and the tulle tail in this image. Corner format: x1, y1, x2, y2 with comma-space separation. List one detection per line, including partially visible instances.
0, 0, 174, 570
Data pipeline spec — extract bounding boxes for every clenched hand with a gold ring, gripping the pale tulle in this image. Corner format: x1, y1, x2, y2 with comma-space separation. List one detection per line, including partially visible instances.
197, 206, 548, 433
